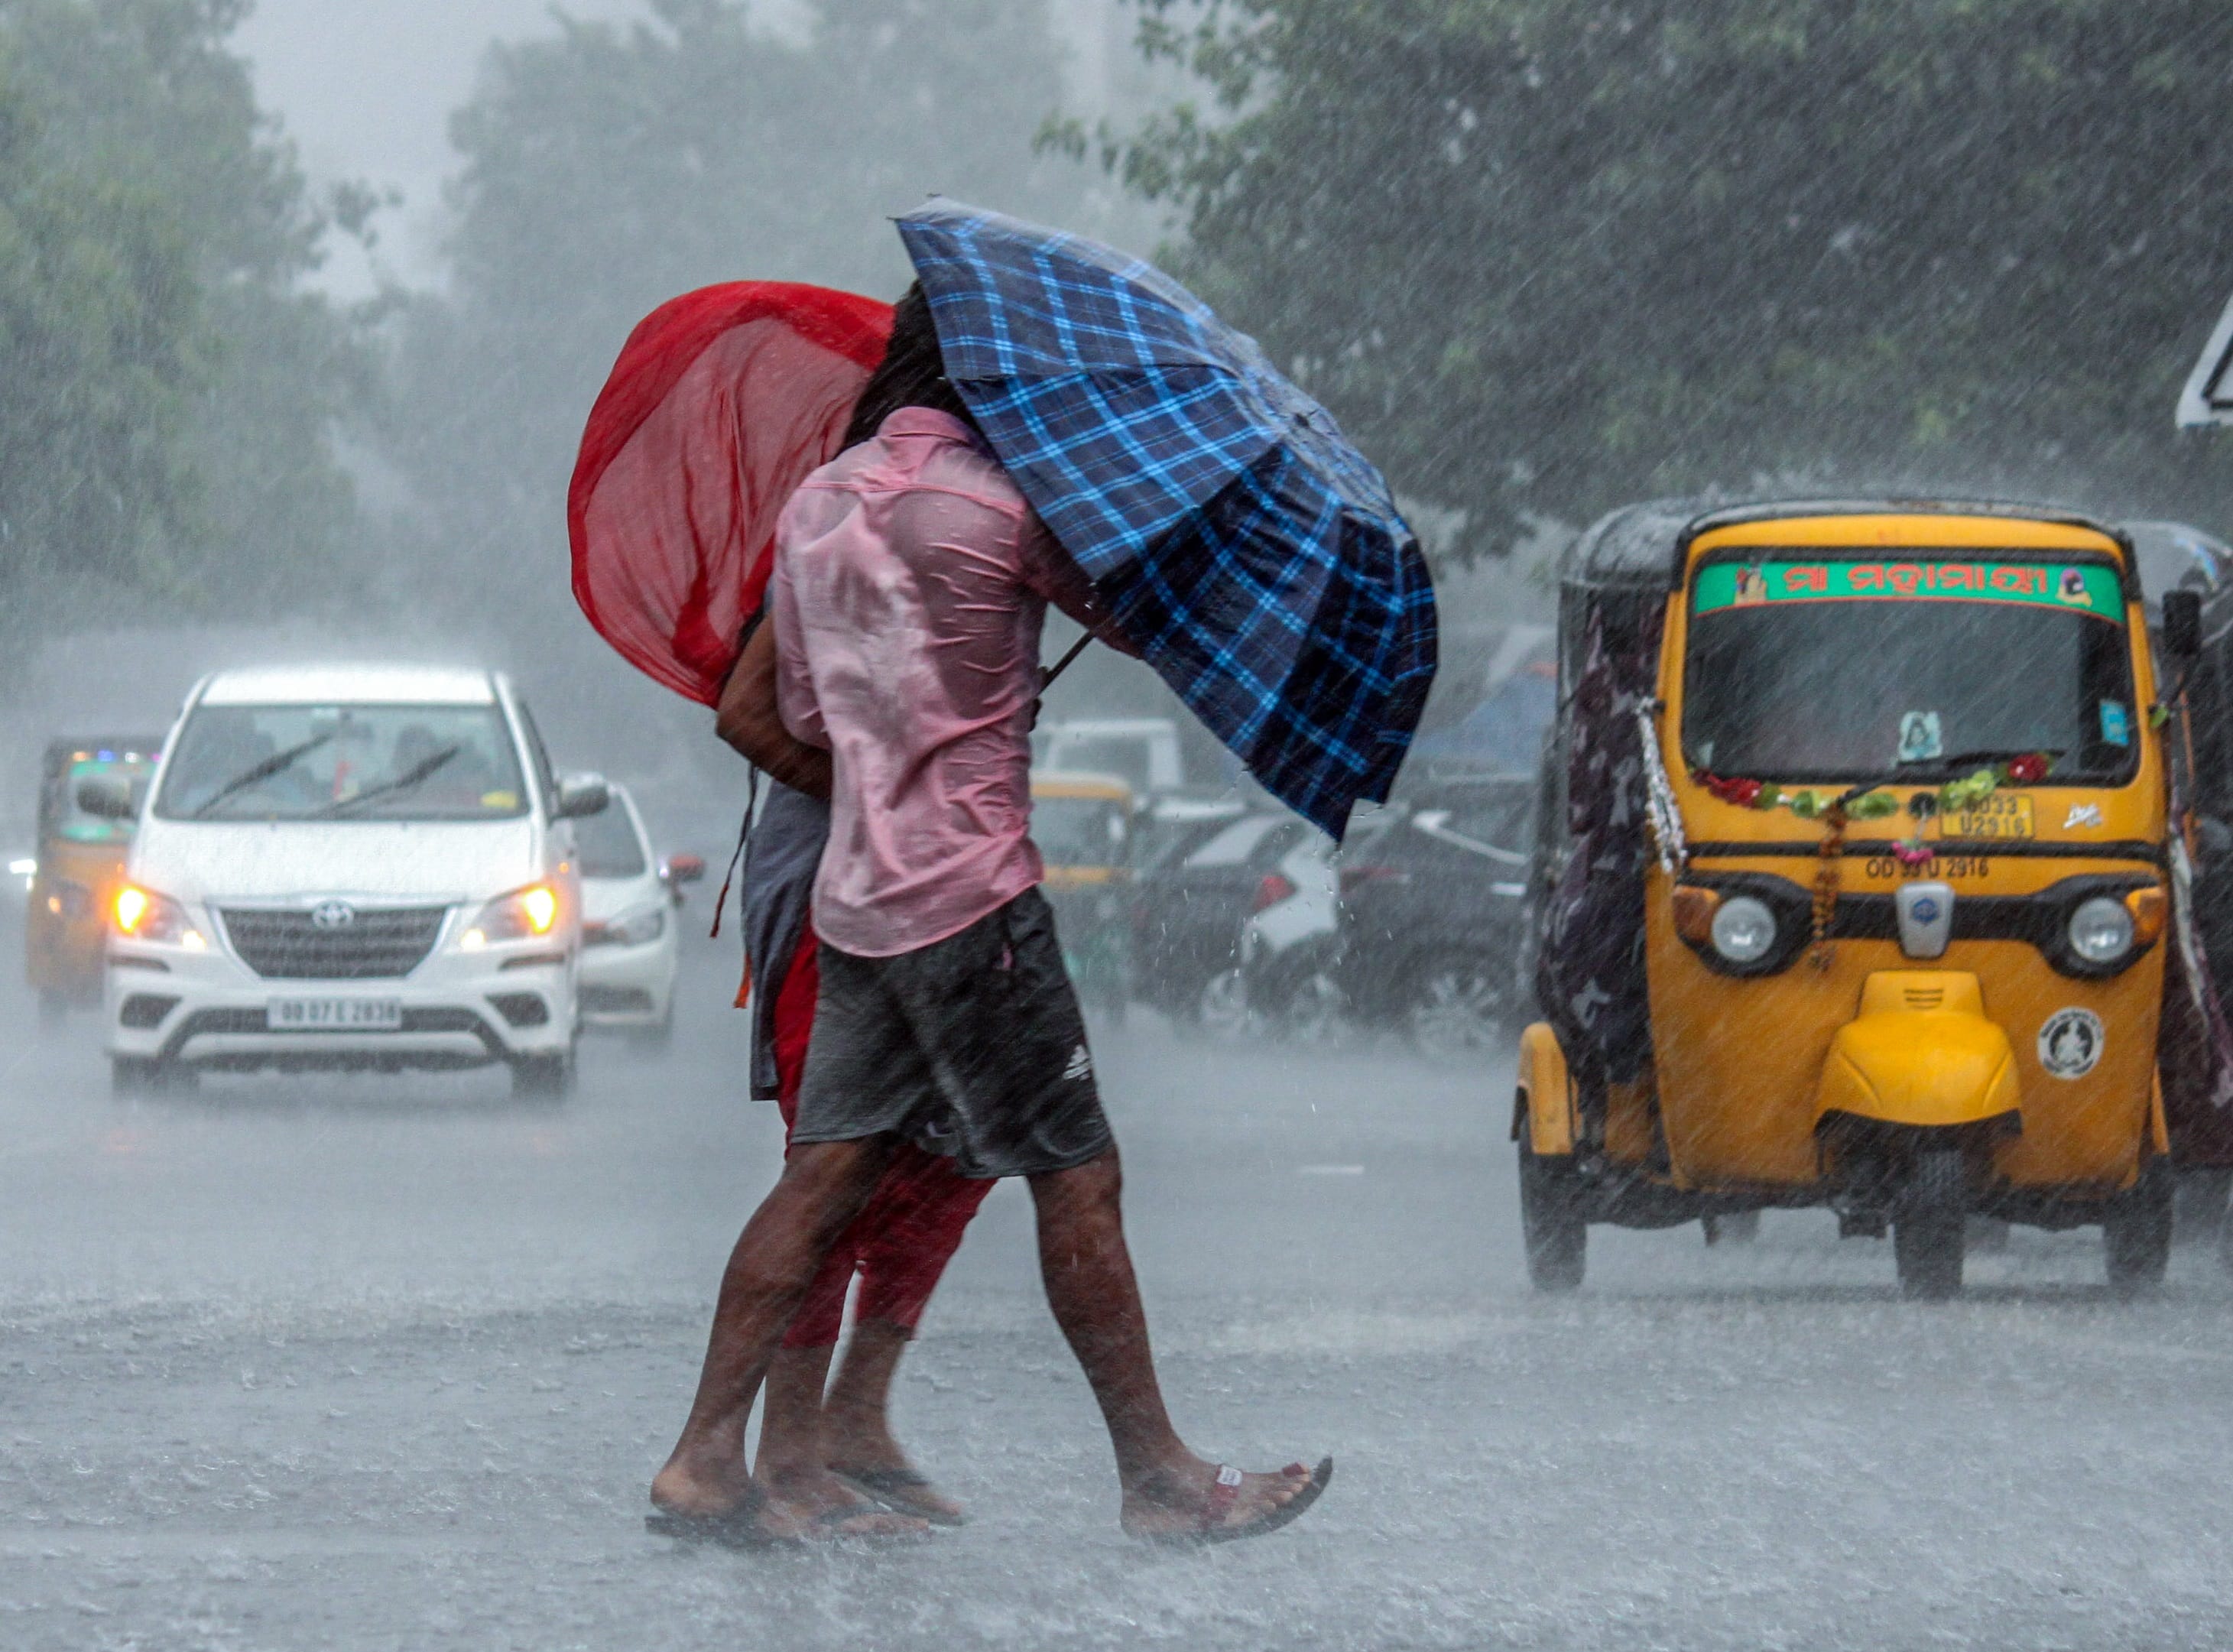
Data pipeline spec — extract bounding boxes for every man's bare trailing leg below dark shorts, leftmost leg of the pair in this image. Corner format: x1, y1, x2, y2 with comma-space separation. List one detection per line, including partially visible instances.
652, 1136, 895, 1536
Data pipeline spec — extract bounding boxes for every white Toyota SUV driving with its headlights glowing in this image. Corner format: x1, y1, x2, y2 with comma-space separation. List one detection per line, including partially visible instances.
78, 665, 608, 1096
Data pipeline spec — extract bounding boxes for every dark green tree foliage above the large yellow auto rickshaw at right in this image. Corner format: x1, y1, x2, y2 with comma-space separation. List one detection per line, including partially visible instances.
1105, 0, 2233, 551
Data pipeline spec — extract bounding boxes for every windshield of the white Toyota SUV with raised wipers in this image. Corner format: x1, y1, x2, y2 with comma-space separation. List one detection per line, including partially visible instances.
156, 706, 527, 820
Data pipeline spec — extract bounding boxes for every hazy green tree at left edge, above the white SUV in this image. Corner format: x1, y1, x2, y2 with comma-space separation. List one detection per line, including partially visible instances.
0, 0, 368, 614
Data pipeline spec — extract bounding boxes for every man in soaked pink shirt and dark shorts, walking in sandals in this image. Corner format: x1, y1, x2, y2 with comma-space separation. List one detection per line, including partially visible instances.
652, 290, 1331, 1543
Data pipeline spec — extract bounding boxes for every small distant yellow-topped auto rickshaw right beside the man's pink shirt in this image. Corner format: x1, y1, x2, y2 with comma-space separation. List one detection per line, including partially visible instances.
1032, 768, 1134, 1021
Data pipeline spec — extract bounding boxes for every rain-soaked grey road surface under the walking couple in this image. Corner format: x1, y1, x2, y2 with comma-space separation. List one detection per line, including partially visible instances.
0, 937, 2233, 1652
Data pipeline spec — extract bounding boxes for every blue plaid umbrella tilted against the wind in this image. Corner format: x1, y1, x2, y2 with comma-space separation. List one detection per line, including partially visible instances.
900, 201, 1436, 837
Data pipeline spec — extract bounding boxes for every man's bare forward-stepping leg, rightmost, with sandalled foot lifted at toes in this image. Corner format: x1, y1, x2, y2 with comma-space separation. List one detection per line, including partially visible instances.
1032, 1147, 1309, 1536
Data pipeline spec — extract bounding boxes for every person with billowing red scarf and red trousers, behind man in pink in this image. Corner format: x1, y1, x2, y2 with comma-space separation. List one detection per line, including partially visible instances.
567, 281, 989, 1538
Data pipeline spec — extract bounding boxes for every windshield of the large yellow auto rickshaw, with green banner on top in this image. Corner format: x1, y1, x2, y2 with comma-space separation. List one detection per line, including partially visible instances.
1682, 558, 2139, 781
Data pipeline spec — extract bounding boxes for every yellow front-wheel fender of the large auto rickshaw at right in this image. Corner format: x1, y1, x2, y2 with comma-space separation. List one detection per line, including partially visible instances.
1816, 969, 2023, 1130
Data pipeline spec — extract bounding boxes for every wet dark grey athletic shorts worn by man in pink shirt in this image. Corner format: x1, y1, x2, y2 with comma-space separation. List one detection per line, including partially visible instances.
790, 888, 1112, 1181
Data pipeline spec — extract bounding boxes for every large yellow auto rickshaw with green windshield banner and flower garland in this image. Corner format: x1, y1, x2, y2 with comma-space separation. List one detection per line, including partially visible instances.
1512, 502, 2199, 1297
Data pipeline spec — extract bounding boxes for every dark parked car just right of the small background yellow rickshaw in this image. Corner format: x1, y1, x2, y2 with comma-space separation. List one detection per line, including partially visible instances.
1132, 810, 1315, 1027
